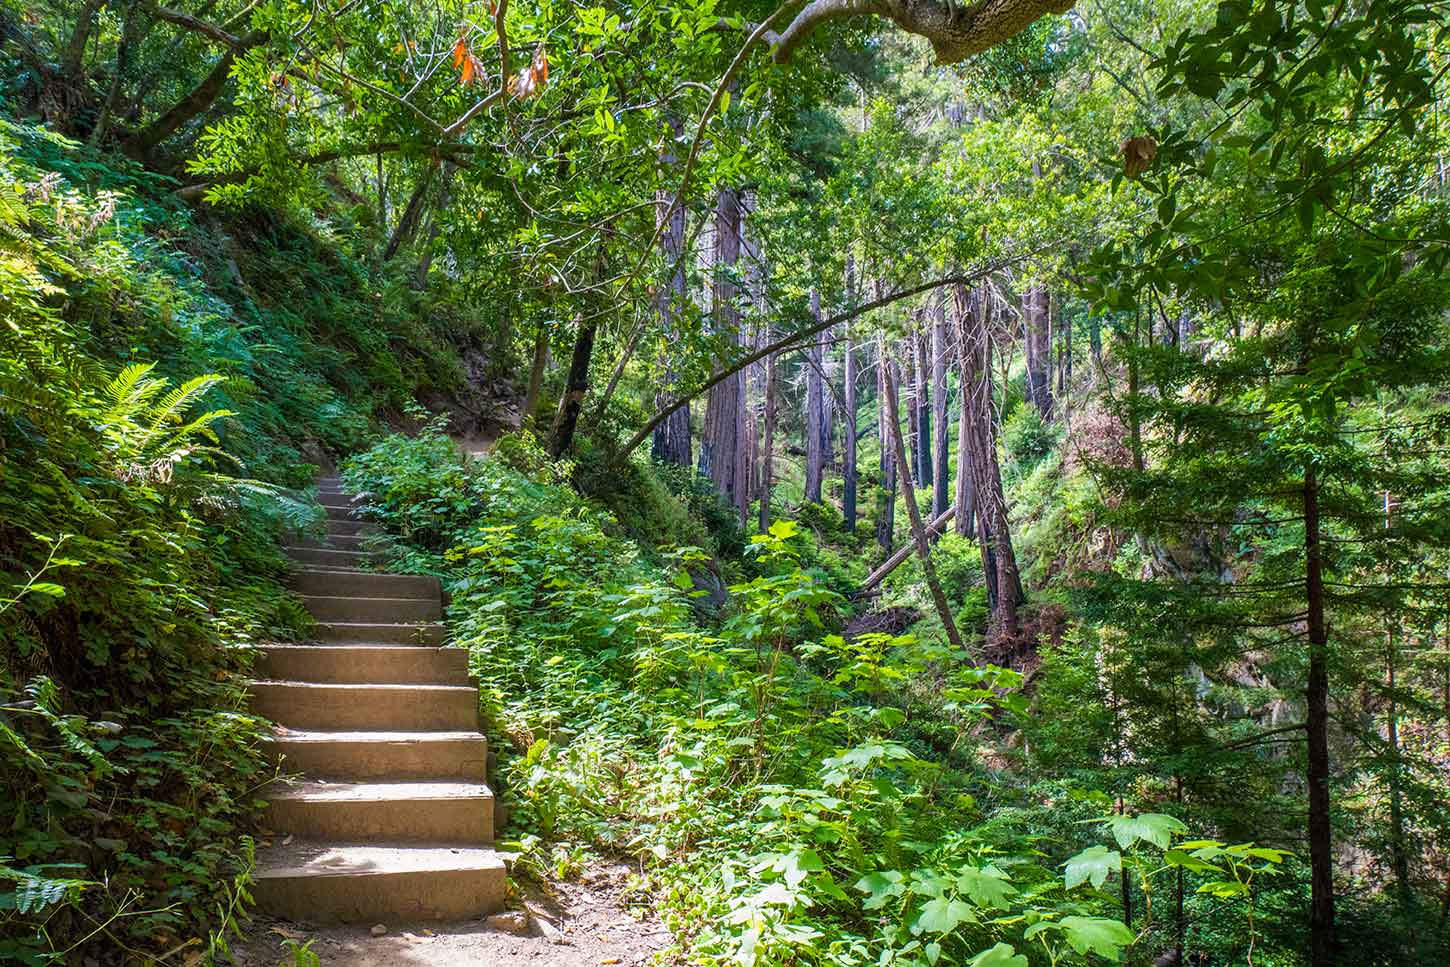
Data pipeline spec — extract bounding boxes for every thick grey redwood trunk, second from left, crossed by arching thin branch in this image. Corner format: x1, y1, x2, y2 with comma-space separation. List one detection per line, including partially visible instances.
700, 187, 744, 507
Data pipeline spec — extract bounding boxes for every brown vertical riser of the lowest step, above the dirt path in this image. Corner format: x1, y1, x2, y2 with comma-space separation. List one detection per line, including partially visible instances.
252, 866, 505, 924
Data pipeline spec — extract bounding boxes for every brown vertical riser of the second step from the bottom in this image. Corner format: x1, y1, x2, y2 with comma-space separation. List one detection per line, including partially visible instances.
264, 796, 493, 847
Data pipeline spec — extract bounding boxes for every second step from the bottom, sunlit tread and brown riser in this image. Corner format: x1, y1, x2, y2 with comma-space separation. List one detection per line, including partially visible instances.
262, 780, 493, 847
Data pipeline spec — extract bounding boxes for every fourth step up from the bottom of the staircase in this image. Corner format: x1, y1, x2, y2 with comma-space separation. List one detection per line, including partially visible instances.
248, 680, 479, 732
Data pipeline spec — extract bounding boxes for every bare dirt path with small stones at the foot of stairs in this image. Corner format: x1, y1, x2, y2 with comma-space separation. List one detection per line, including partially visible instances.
232, 866, 671, 967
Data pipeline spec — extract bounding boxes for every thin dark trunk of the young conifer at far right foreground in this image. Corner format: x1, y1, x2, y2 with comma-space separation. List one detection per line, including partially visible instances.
1304, 467, 1335, 967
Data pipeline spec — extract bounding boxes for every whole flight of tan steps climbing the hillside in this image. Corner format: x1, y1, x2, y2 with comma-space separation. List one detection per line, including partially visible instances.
251, 477, 505, 922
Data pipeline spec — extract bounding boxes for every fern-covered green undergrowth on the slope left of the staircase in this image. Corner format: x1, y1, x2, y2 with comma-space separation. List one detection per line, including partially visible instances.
0, 113, 454, 964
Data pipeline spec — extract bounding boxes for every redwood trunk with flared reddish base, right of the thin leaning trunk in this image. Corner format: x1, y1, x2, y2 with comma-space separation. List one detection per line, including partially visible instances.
957, 287, 1024, 638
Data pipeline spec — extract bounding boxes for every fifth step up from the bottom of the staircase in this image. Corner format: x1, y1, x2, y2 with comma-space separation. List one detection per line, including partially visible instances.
252, 645, 468, 686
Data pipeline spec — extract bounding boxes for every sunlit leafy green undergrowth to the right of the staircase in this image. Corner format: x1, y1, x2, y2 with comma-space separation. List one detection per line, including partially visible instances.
344, 429, 1280, 967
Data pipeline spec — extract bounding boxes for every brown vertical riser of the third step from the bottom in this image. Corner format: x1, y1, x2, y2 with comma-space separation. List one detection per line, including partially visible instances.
271, 736, 489, 783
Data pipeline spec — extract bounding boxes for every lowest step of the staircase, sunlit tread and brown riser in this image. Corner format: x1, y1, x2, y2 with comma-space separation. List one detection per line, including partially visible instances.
252, 841, 505, 924
